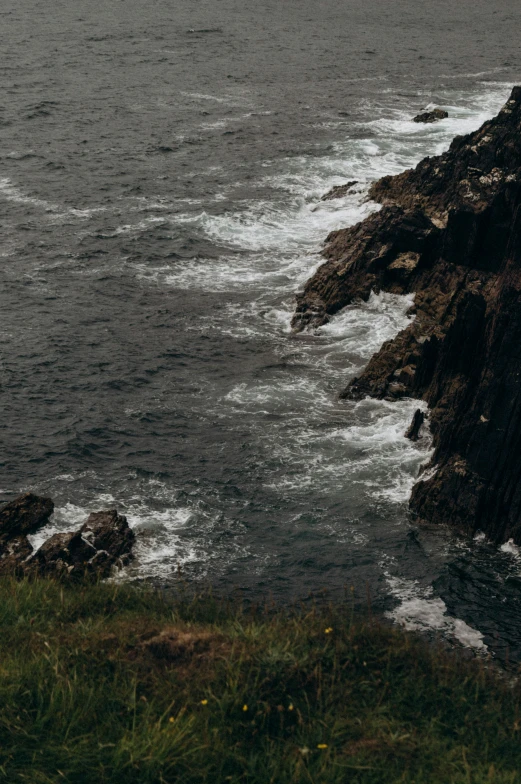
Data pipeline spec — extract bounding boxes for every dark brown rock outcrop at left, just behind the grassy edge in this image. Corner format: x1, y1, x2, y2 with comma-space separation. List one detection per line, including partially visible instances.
0, 493, 135, 578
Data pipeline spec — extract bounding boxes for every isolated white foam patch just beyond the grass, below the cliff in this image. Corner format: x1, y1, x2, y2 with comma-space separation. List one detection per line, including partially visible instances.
385, 573, 488, 653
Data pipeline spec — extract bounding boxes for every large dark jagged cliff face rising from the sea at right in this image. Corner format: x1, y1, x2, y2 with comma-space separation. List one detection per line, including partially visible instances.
293, 87, 521, 542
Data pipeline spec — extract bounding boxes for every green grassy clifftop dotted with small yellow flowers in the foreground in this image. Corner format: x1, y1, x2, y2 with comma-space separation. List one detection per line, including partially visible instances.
0, 578, 521, 784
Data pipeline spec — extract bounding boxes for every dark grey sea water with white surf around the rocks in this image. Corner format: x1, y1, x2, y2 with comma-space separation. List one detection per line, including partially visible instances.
0, 0, 521, 659
